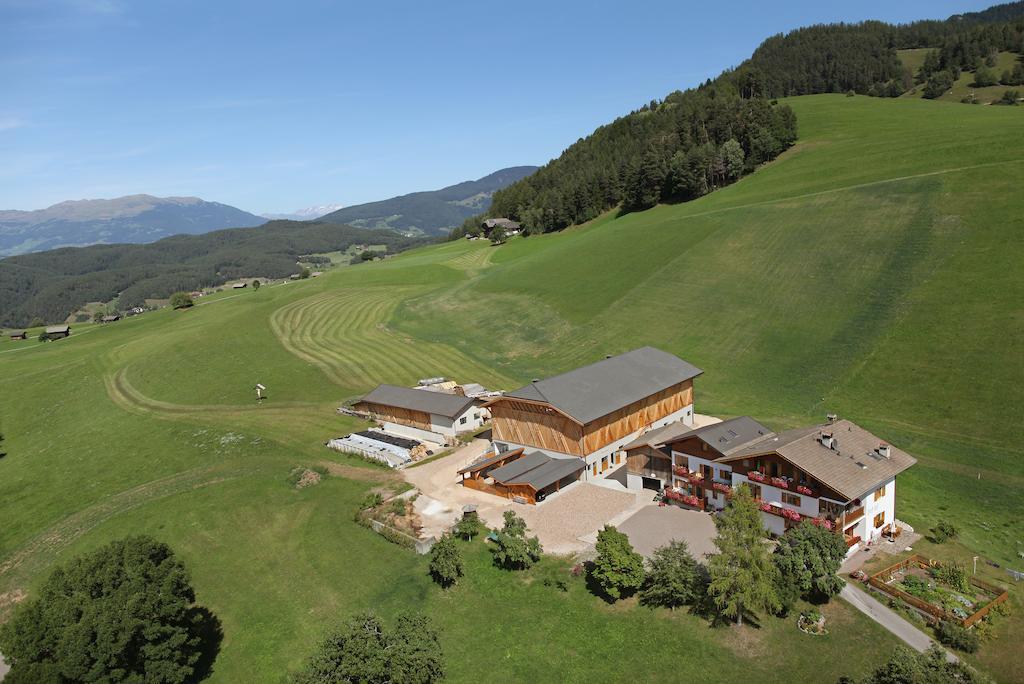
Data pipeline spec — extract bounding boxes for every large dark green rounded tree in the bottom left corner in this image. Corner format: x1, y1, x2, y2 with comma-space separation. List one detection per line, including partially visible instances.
0, 537, 215, 682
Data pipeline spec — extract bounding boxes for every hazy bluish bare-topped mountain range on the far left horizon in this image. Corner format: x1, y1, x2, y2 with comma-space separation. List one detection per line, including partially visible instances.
0, 195, 267, 257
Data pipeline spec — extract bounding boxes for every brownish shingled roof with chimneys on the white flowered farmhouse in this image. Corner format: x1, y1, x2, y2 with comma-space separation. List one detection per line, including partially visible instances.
720, 420, 918, 500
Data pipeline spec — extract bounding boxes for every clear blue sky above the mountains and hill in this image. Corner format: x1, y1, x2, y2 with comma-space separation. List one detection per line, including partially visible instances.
0, 0, 995, 212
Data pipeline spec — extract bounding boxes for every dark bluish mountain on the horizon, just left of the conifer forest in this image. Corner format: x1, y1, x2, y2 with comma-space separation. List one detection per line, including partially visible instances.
319, 166, 537, 236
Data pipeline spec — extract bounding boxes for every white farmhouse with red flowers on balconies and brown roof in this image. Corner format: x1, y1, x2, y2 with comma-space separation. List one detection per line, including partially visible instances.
660, 417, 916, 553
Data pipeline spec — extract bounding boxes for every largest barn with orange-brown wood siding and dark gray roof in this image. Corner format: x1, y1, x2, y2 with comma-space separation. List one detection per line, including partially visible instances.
484, 347, 702, 479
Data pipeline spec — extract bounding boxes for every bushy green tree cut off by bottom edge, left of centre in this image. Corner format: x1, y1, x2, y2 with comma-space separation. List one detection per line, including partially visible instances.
292, 612, 444, 684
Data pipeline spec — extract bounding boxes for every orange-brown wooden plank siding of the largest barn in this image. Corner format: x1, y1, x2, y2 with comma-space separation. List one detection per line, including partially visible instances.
489, 380, 693, 457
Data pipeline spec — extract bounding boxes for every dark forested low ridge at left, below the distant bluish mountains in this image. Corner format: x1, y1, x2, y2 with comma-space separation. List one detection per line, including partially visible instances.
0, 221, 425, 326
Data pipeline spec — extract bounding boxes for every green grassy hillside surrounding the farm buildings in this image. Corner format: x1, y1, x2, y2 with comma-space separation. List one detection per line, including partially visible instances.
0, 95, 1024, 681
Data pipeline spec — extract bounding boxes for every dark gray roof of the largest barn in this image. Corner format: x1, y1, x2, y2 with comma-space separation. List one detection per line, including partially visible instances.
505, 347, 703, 424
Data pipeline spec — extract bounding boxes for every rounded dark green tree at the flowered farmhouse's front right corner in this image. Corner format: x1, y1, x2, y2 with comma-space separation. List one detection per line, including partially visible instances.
774, 520, 846, 610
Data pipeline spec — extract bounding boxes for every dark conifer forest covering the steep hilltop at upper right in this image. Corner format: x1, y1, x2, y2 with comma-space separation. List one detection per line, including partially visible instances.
471, 2, 1024, 238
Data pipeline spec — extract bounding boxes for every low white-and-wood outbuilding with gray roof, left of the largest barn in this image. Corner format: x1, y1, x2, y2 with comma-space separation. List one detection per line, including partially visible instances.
353, 385, 487, 444
